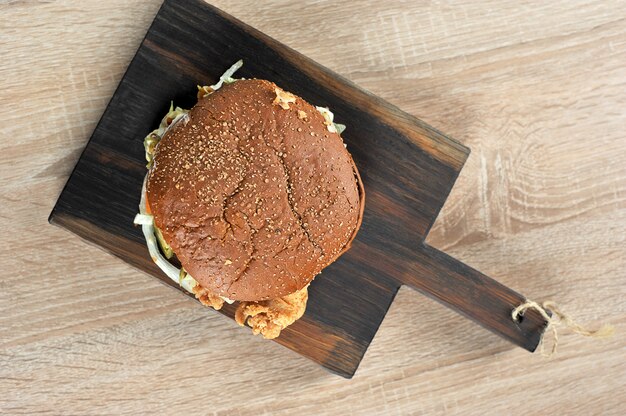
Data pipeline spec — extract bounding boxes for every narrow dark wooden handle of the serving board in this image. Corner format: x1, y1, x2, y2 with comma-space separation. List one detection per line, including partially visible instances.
401, 244, 547, 352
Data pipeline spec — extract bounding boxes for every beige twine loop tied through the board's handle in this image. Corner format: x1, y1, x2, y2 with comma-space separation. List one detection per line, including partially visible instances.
511, 299, 615, 357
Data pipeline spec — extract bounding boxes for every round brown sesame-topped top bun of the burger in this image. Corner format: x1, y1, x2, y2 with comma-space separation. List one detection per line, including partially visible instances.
147, 80, 364, 301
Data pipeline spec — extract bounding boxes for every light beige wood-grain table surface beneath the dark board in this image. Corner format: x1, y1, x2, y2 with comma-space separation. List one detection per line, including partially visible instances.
0, 0, 626, 415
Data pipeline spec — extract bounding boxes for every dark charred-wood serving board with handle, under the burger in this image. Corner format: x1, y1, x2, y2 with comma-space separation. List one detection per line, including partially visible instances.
50, 0, 546, 377
